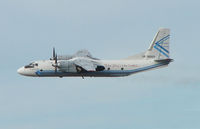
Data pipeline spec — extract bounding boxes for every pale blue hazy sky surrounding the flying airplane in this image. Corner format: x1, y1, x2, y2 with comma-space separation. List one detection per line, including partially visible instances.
0, 0, 200, 129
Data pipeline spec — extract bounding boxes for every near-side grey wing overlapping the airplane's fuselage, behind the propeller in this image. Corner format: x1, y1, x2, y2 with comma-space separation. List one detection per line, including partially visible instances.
74, 59, 97, 71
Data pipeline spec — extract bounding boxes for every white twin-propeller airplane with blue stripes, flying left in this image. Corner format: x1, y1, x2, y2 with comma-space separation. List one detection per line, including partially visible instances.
17, 28, 173, 78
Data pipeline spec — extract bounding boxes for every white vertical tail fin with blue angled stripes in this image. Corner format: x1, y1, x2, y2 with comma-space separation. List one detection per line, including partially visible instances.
145, 28, 170, 60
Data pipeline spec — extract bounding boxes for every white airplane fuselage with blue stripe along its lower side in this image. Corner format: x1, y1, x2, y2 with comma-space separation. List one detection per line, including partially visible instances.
18, 59, 168, 77
